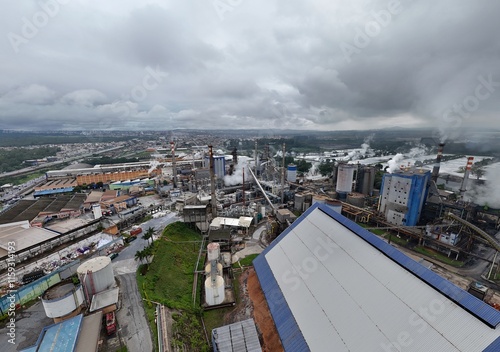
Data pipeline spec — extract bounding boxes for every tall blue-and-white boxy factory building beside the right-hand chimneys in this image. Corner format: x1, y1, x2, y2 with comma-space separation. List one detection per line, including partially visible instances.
378, 169, 431, 226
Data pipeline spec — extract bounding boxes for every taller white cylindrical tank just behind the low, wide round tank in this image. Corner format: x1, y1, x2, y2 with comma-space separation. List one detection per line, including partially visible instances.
76, 256, 115, 299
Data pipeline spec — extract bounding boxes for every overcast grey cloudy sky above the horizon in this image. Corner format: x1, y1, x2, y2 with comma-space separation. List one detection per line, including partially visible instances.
0, 0, 500, 138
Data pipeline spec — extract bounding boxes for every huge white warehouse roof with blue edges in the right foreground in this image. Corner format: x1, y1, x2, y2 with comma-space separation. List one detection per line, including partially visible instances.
254, 204, 500, 351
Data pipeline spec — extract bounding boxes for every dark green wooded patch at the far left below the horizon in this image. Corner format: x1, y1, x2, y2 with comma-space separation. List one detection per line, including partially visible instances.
0, 147, 59, 173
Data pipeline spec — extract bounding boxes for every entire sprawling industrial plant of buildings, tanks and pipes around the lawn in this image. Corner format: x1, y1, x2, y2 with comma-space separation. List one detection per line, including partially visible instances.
0, 131, 500, 352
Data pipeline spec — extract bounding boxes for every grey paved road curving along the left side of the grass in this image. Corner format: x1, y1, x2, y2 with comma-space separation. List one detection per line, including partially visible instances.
113, 213, 179, 352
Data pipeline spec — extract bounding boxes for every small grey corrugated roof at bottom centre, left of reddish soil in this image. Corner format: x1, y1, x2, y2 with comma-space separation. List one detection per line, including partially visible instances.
212, 319, 262, 352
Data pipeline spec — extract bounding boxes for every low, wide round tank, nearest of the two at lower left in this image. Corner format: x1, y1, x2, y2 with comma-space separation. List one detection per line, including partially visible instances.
42, 280, 85, 323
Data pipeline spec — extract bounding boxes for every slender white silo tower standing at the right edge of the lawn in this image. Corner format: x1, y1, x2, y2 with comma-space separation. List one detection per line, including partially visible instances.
205, 242, 225, 306
